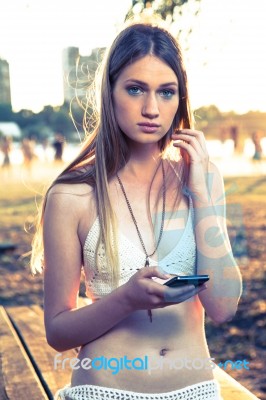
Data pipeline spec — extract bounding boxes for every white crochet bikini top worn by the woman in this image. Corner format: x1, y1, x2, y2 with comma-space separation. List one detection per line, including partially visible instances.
83, 199, 196, 300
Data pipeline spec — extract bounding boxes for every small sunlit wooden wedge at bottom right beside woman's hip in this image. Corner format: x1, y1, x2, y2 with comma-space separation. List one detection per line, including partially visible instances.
213, 366, 259, 400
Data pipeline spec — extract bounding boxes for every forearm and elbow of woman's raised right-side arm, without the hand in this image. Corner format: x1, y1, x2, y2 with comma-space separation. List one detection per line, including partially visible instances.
193, 164, 242, 323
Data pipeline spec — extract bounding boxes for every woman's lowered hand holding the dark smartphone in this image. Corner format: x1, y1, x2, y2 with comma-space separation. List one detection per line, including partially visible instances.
120, 267, 207, 311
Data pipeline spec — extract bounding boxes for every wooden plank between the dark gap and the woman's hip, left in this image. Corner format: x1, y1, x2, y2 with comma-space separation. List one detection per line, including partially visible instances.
7, 305, 77, 399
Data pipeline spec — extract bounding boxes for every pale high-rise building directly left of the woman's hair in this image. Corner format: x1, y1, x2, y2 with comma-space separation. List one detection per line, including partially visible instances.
63, 47, 105, 103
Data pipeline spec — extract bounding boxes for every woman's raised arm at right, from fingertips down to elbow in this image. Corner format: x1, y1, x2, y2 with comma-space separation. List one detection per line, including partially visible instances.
173, 129, 242, 323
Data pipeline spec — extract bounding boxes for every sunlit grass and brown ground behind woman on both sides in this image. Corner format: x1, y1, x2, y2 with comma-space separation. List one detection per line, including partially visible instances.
0, 173, 266, 400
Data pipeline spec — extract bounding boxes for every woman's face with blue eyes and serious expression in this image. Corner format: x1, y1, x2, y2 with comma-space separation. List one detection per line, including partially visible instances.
113, 55, 179, 148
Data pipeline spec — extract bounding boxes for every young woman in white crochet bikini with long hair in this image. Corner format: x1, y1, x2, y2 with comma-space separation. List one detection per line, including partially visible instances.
32, 24, 241, 400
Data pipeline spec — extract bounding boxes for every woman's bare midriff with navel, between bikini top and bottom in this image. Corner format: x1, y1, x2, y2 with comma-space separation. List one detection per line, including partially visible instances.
72, 296, 213, 393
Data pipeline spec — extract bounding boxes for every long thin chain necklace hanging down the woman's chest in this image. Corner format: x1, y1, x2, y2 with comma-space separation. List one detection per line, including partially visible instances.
116, 162, 166, 322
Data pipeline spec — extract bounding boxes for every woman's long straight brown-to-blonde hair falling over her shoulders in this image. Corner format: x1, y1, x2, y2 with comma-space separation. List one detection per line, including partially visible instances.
31, 23, 192, 284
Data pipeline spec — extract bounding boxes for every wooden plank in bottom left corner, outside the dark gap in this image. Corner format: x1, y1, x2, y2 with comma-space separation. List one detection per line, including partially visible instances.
0, 306, 48, 400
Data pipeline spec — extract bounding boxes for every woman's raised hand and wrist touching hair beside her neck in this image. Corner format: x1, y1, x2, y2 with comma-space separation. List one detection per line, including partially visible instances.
172, 129, 209, 201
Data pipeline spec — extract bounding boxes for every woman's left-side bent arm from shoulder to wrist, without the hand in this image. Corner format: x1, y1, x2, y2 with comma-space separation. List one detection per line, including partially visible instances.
44, 185, 139, 351
